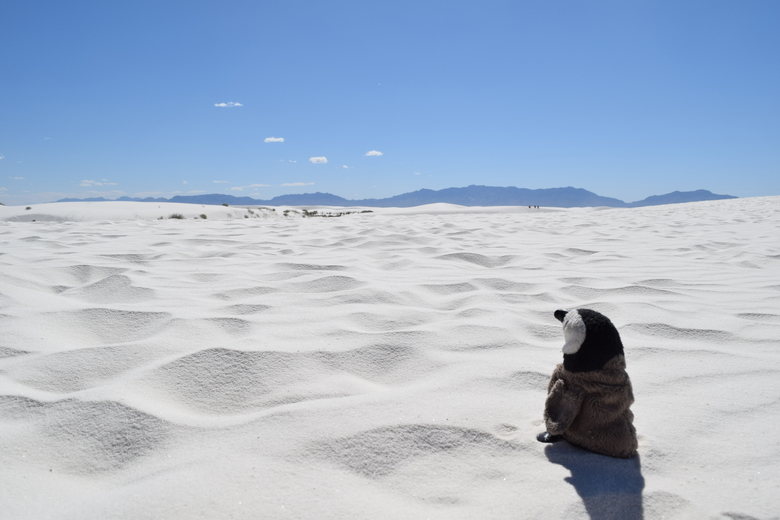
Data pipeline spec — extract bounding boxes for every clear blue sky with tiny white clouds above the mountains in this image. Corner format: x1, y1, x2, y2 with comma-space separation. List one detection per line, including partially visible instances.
0, 0, 780, 204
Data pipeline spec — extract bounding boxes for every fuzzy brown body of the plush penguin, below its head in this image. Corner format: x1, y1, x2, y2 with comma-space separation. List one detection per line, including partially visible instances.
544, 356, 637, 458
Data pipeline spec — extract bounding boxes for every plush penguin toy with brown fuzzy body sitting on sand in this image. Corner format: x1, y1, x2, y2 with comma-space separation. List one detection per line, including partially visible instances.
537, 309, 637, 458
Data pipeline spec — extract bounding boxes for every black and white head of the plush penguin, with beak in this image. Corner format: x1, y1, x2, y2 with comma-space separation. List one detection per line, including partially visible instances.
555, 309, 623, 372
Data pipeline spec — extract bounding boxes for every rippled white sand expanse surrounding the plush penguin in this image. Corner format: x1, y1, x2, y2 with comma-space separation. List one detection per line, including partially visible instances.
0, 197, 780, 520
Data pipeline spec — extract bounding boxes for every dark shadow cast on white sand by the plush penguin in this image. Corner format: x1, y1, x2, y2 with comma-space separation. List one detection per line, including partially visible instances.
544, 442, 645, 520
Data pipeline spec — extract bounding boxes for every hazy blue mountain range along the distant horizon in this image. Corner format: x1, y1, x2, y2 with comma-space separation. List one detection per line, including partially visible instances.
57, 186, 736, 208
